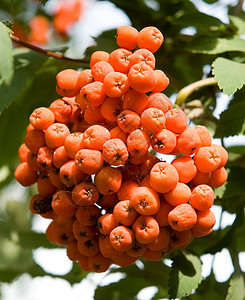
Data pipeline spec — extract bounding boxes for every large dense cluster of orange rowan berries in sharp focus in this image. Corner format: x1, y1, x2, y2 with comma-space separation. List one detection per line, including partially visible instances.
15, 26, 227, 272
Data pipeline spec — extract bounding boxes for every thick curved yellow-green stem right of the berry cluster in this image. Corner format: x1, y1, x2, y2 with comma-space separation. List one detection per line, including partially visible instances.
175, 77, 218, 106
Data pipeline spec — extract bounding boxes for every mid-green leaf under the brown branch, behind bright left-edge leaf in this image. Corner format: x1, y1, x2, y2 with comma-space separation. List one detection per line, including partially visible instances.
0, 49, 47, 114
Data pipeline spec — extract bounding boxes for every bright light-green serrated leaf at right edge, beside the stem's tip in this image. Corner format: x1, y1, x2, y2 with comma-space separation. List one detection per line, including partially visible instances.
212, 57, 245, 95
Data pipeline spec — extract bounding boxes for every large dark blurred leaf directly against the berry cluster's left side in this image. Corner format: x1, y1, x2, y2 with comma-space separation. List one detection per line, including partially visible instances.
0, 59, 77, 166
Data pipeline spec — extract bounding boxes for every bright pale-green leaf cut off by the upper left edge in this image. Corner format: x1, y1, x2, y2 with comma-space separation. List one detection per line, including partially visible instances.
0, 22, 14, 85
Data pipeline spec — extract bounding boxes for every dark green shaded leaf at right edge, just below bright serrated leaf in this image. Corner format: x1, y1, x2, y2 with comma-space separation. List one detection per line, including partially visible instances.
214, 89, 245, 138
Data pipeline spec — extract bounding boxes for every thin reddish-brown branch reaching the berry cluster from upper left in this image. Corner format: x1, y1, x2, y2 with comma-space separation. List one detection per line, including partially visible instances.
10, 34, 89, 67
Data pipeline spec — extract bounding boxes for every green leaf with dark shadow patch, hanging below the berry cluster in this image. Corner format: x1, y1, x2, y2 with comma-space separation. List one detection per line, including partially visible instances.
168, 253, 202, 299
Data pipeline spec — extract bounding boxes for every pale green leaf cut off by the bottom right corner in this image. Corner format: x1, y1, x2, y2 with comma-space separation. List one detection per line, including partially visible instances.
225, 272, 245, 300
